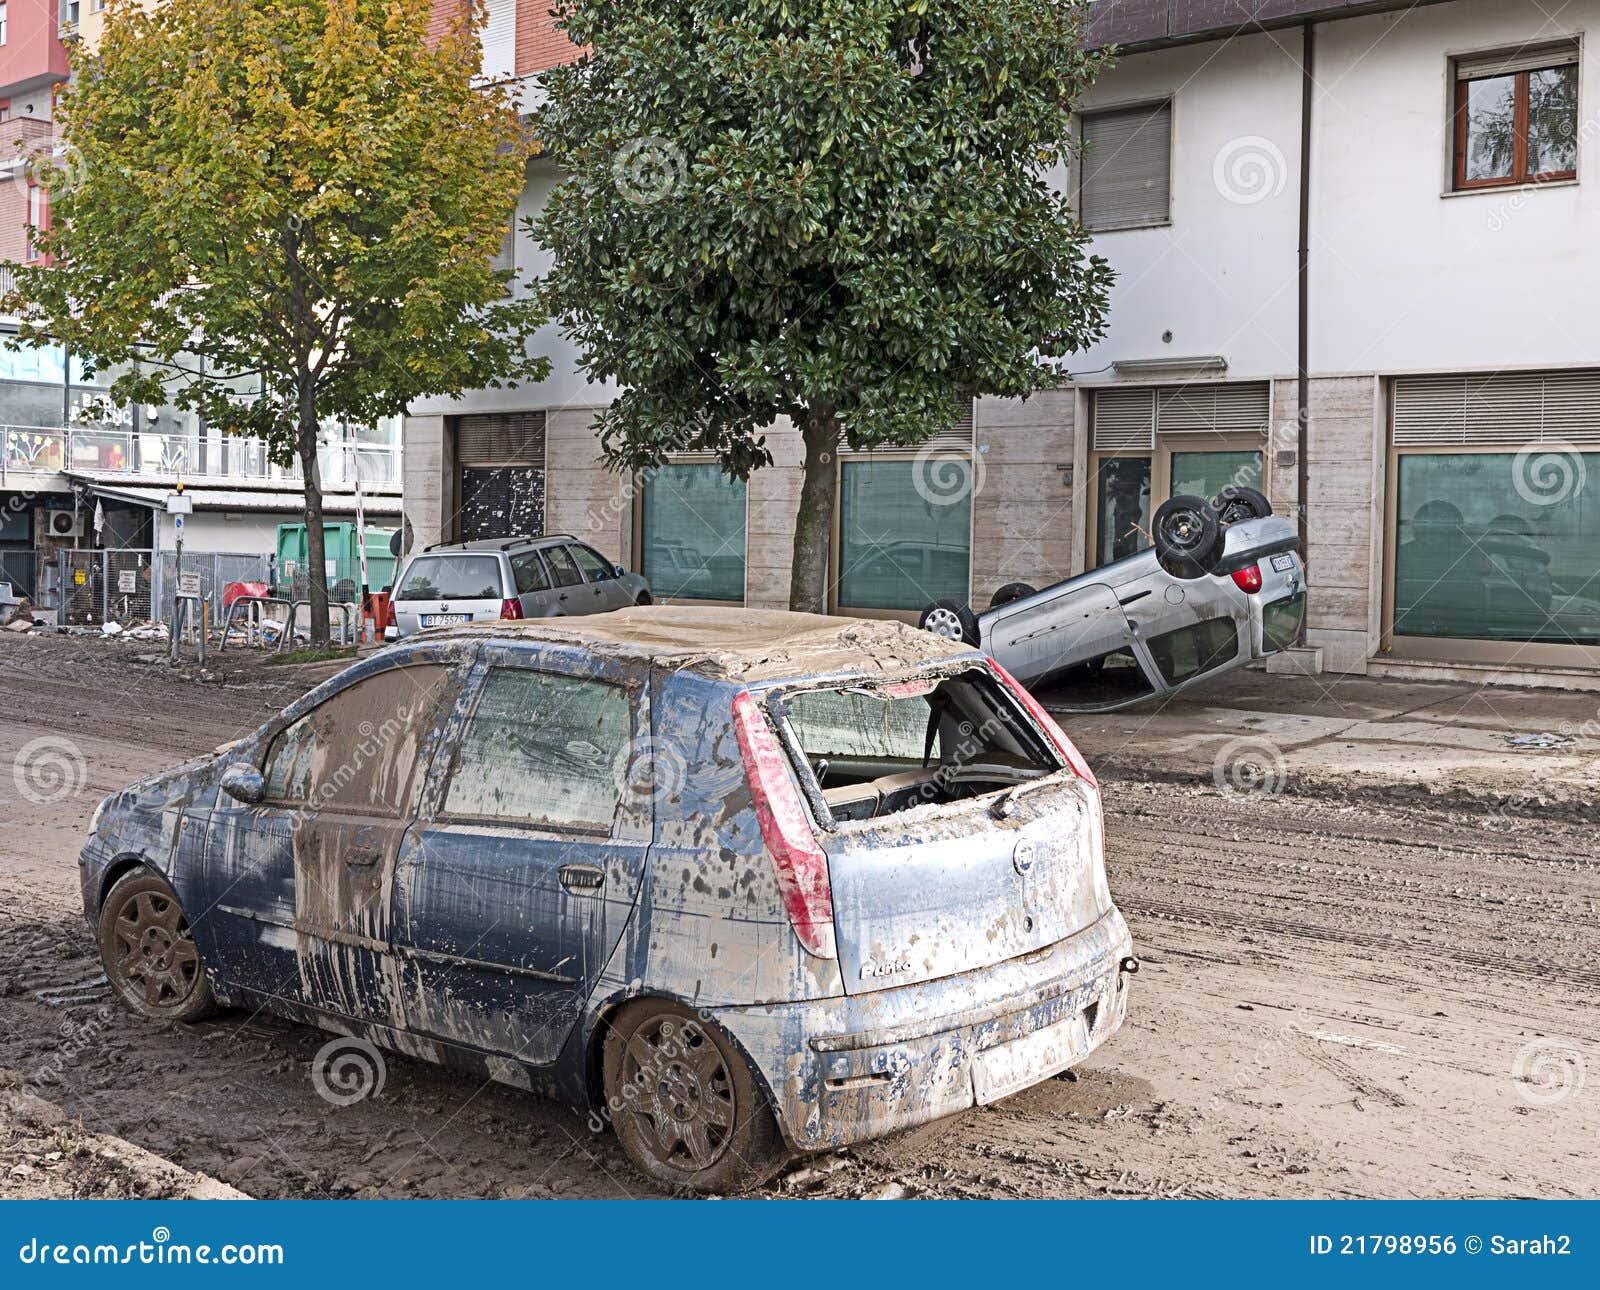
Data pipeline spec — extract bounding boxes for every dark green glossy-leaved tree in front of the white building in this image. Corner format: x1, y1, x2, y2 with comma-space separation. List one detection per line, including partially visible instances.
534, 0, 1110, 611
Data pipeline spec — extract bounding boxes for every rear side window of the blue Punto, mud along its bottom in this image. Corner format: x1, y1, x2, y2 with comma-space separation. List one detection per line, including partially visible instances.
443, 667, 632, 832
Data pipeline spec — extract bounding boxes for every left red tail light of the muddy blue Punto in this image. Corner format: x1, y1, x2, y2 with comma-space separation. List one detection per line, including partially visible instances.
733, 690, 838, 959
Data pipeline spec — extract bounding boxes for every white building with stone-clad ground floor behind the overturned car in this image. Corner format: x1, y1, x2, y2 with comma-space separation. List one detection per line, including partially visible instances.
428, 0, 1600, 688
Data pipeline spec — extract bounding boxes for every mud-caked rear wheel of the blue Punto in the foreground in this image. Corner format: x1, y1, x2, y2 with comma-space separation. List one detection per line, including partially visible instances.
602, 999, 789, 1196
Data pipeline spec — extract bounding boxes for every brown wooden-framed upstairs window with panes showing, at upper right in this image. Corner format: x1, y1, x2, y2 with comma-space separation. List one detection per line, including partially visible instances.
1454, 45, 1578, 189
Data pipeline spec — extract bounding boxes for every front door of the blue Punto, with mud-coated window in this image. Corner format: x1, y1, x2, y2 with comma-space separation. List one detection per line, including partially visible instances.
194, 662, 470, 1024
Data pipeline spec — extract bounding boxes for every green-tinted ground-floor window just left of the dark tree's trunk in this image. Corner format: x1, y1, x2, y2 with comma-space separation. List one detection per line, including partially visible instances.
638, 461, 746, 605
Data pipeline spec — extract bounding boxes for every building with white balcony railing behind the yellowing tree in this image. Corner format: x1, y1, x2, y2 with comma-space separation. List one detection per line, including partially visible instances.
0, 0, 400, 611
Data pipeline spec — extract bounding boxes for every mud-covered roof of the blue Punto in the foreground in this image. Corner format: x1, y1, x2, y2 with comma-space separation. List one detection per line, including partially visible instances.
411, 605, 978, 682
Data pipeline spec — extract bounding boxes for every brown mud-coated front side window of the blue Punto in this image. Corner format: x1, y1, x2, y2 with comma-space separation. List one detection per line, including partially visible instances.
262, 664, 450, 815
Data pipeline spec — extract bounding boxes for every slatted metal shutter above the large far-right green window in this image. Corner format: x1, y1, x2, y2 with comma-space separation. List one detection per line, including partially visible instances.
1392, 371, 1600, 448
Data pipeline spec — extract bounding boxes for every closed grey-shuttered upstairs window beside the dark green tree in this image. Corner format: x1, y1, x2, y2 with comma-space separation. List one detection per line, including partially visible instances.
1078, 102, 1173, 232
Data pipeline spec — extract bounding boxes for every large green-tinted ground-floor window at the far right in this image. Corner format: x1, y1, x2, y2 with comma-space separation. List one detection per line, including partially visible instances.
1394, 445, 1600, 645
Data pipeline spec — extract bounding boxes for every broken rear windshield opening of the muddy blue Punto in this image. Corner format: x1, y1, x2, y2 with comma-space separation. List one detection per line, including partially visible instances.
774, 669, 1058, 819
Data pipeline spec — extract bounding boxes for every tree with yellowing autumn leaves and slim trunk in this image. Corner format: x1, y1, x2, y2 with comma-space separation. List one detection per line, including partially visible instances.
0, 0, 547, 642
